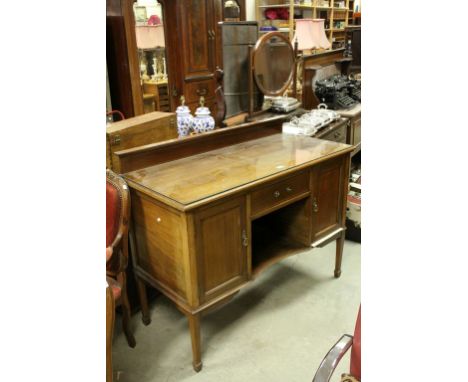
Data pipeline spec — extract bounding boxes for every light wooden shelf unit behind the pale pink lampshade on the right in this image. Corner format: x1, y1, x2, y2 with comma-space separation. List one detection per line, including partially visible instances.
255, 0, 354, 49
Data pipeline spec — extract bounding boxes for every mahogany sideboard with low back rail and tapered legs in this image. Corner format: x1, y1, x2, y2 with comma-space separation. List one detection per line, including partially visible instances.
115, 123, 353, 371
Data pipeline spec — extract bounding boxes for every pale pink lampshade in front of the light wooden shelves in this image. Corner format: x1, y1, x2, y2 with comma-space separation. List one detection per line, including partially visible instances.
293, 19, 331, 50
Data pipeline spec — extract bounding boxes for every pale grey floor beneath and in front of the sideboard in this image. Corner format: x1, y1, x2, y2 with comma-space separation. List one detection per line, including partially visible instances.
113, 241, 361, 382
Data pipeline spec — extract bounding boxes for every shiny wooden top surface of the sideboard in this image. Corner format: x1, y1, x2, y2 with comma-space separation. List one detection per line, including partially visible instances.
125, 134, 352, 205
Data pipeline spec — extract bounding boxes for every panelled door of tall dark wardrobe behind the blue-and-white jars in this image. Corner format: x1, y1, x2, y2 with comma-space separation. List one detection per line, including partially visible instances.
180, 0, 215, 80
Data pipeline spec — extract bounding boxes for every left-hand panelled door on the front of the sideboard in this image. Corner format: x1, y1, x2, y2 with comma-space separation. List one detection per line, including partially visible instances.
195, 197, 249, 303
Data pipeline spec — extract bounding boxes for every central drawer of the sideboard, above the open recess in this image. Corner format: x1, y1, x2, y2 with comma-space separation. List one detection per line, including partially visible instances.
250, 172, 309, 218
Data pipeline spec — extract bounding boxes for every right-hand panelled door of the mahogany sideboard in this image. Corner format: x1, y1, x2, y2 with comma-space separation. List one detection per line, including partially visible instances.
311, 157, 347, 242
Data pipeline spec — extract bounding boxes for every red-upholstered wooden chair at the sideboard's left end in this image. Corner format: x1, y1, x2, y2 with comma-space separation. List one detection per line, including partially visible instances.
106, 170, 136, 348
